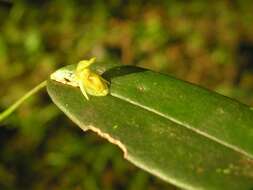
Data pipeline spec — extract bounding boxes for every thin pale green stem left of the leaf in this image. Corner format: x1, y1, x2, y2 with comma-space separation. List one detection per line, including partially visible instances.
0, 81, 47, 122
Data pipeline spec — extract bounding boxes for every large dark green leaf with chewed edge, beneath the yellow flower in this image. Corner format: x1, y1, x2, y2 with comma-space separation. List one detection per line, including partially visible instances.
47, 65, 253, 190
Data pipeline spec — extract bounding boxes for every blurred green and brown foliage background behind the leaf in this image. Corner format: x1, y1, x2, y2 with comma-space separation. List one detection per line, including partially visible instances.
0, 0, 253, 190
